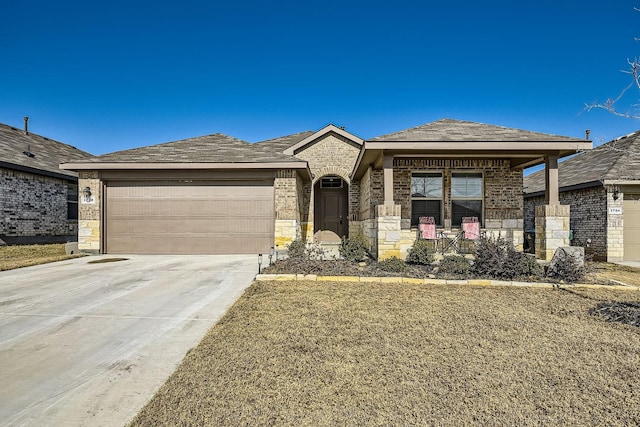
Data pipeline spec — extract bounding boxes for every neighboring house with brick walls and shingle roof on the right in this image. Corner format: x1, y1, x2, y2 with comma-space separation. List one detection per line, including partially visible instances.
524, 132, 640, 261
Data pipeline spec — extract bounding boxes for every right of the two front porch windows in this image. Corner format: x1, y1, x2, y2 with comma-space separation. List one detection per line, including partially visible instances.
451, 172, 483, 227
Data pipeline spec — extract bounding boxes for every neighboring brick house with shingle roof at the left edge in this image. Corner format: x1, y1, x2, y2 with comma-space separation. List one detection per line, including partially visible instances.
0, 120, 90, 244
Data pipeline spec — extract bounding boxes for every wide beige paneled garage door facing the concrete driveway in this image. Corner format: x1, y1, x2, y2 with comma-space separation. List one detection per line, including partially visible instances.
105, 181, 275, 254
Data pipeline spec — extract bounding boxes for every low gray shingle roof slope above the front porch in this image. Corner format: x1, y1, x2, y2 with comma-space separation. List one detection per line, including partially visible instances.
369, 119, 584, 142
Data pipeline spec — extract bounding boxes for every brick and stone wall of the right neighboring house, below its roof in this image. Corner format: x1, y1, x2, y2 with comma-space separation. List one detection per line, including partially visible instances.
524, 186, 608, 260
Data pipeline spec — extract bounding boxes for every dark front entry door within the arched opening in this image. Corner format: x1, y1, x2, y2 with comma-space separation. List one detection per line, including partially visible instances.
314, 177, 349, 241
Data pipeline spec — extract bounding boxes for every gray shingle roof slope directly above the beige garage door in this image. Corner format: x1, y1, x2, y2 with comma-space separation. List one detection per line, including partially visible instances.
83, 133, 299, 163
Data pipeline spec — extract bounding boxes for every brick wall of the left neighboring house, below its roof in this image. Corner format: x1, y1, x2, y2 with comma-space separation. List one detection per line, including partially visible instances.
0, 168, 78, 244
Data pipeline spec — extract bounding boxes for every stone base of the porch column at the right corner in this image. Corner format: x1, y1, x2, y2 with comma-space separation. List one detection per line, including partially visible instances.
536, 205, 571, 261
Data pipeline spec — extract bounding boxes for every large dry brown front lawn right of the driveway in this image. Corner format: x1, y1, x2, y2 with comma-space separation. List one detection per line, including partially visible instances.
132, 282, 640, 426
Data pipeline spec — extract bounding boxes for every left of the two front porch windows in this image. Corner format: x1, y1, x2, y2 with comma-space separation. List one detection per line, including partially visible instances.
411, 172, 443, 226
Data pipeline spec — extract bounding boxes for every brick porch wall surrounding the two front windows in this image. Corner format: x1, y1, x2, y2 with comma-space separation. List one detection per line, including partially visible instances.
392, 159, 523, 229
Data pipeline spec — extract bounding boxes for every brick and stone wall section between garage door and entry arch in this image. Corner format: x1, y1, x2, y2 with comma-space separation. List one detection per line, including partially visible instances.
273, 169, 303, 249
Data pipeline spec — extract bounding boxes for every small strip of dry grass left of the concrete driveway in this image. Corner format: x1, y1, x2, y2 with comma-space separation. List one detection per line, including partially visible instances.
0, 243, 82, 271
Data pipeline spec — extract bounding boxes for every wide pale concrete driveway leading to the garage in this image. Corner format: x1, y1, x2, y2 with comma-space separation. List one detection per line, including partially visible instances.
0, 255, 258, 426
